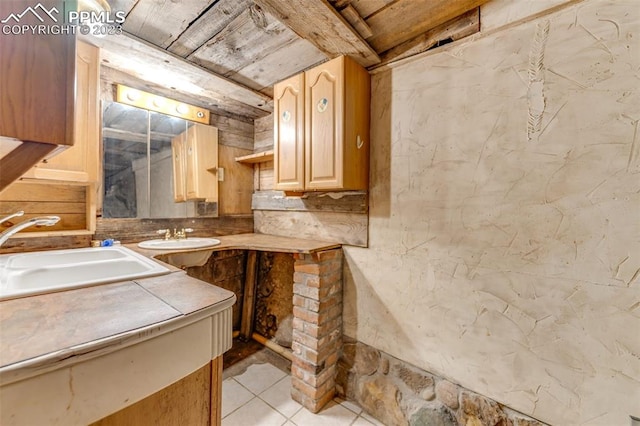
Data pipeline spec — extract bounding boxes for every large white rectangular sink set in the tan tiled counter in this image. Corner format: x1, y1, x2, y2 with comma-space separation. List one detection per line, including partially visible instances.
0, 247, 169, 300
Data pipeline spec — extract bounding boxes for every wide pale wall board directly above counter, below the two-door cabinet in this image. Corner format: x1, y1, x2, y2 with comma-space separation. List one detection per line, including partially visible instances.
253, 210, 368, 247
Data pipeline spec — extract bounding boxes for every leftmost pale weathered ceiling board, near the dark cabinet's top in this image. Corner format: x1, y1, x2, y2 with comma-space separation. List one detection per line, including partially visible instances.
122, 0, 210, 49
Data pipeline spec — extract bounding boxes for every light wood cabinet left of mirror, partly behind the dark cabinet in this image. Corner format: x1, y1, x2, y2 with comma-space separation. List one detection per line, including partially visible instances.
23, 41, 100, 182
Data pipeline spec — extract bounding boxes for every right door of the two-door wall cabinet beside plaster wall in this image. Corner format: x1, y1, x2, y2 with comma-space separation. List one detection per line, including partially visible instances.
305, 57, 344, 189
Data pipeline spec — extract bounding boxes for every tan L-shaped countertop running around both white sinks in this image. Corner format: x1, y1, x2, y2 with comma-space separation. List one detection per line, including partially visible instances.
0, 234, 340, 382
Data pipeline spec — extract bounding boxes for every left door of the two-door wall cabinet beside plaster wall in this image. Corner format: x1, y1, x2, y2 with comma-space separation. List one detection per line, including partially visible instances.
273, 74, 304, 191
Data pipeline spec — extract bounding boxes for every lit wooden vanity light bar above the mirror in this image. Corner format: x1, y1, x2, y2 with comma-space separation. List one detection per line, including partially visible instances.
116, 84, 209, 124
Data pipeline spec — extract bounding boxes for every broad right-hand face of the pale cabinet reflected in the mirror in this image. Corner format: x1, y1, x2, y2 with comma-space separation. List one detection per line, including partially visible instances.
185, 124, 218, 202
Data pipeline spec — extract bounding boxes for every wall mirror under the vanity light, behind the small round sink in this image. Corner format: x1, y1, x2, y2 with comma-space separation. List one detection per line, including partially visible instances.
102, 101, 218, 219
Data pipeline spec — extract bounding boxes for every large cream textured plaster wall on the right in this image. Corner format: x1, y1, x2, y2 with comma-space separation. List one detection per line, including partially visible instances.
344, 0, 640, 425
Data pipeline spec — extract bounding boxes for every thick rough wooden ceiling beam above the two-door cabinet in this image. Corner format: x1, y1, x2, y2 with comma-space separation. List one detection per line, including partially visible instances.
255, 0, 380, 67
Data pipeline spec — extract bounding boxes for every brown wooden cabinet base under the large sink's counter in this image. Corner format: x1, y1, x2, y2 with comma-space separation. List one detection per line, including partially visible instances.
92, 356, 222, 426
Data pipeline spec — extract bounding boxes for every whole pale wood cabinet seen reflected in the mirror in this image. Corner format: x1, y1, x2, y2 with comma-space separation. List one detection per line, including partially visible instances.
171, 125, 218, 202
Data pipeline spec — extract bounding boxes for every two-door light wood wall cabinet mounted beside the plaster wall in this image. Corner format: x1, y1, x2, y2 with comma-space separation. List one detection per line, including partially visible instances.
274, 56, 371, 191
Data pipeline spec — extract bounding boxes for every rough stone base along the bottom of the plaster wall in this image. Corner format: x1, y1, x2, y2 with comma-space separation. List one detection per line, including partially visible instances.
336, 338, 543, 426
